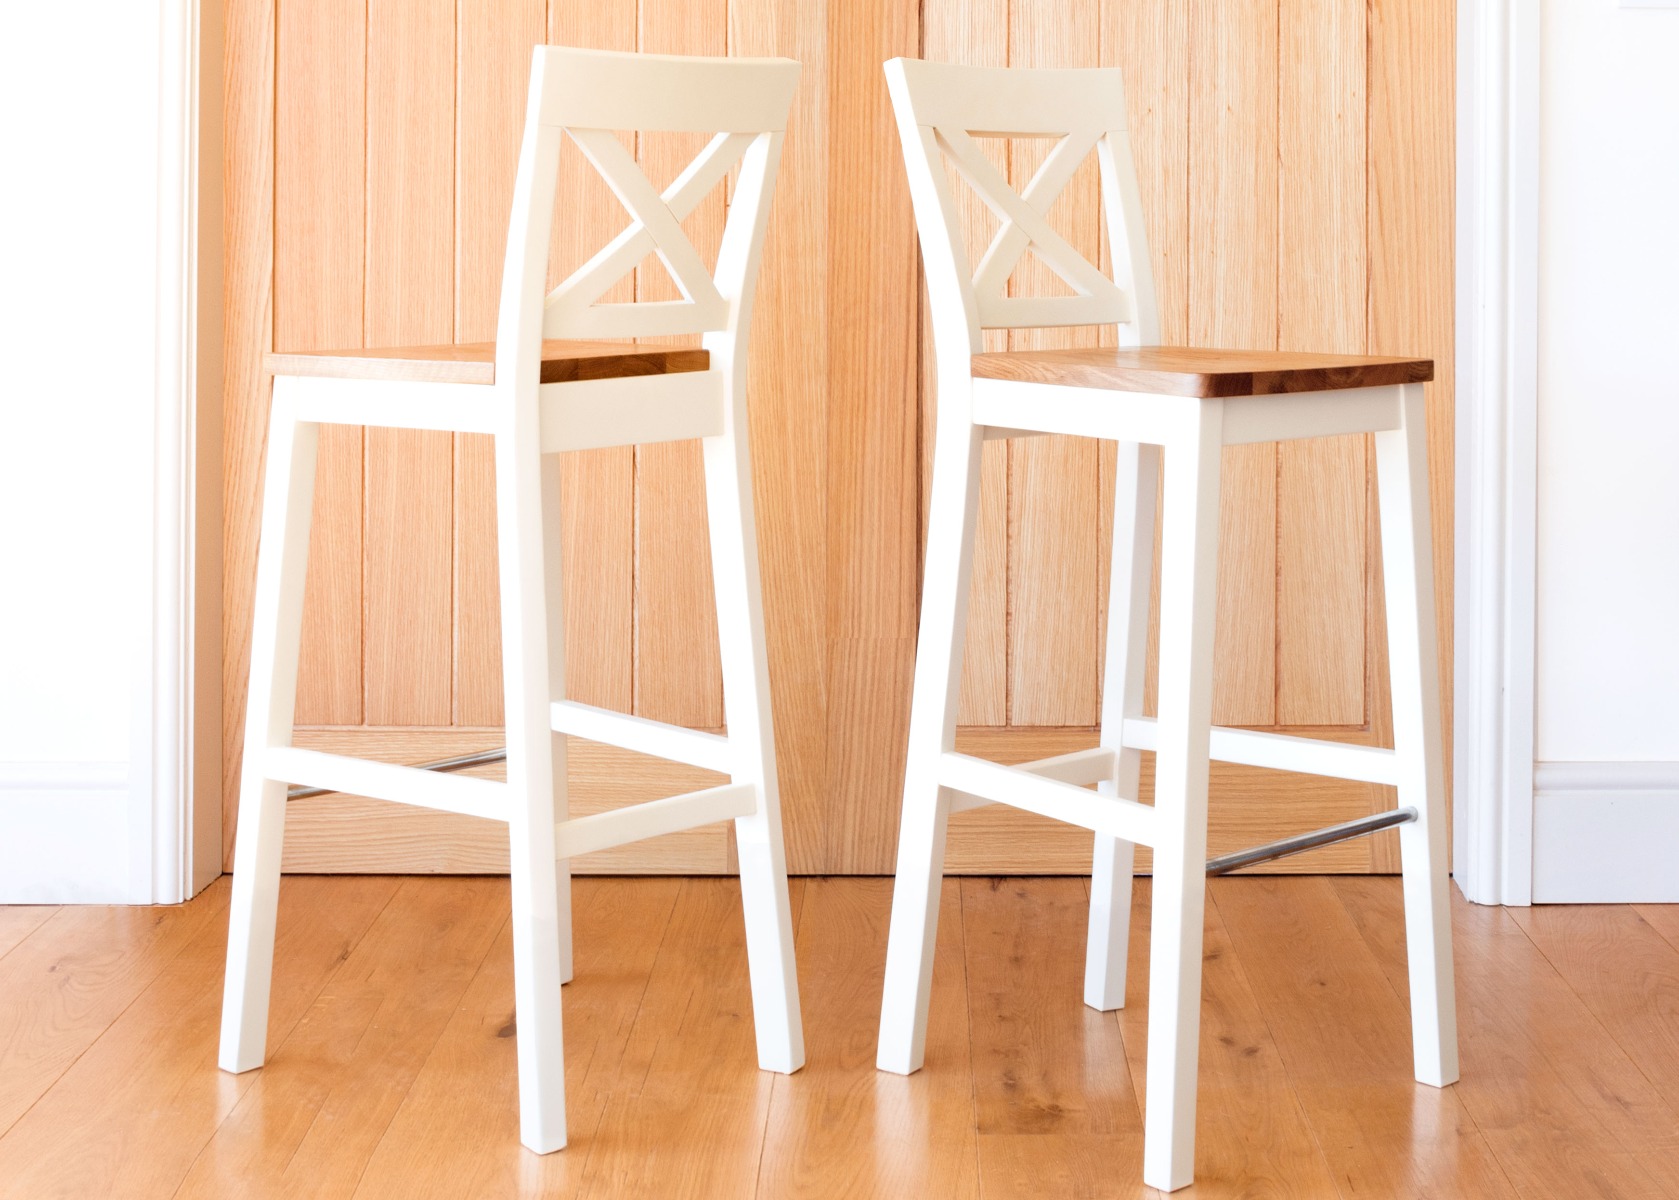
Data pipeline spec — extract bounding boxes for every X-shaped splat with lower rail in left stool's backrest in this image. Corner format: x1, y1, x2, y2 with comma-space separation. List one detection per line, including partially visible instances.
542, 129, 762, 337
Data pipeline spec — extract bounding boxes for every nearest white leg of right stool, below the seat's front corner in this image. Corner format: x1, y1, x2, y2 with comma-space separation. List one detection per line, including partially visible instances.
1143, 399, 1224, 1192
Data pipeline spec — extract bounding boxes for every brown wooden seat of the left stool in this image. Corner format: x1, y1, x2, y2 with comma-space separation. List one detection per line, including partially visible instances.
262, 341, 712, 384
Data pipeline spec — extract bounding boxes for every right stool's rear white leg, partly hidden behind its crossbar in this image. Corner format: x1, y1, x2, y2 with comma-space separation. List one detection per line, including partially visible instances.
1085, 441, 1160, 1012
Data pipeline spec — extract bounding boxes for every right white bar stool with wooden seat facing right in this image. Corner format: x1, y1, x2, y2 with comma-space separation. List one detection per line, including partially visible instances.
878, 59, 1457, 1190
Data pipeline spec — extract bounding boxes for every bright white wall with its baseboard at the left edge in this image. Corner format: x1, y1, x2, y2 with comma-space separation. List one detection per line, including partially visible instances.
0, 0, 158, 901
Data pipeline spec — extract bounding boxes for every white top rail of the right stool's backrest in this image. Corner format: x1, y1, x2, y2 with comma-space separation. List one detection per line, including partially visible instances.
887, 59, 1127, 138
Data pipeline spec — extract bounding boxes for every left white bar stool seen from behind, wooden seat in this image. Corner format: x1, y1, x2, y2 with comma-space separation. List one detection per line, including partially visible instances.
220, 47, 804, 1153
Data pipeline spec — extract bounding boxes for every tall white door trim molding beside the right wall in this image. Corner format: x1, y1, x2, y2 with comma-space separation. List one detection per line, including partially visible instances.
1452, 0, 1540, 905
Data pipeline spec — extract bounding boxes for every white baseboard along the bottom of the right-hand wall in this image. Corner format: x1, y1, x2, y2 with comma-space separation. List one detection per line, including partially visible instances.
1533, 762, 1679, 905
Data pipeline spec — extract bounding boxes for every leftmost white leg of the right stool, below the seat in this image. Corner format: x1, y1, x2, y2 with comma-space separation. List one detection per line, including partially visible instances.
875, 417, 984, 1074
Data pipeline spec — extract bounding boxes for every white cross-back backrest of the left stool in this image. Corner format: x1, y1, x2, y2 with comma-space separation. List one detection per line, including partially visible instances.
497, 45, 799, 383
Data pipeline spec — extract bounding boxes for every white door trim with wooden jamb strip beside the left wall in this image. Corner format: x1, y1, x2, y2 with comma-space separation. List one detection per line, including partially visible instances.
139, 0, 222, 903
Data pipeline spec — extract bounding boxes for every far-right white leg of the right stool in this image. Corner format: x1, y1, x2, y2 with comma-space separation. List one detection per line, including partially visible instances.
1375, 384, 1457, 1088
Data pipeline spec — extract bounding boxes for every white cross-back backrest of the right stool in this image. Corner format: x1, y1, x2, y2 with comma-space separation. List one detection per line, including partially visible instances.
887, 59, 1160, 374
